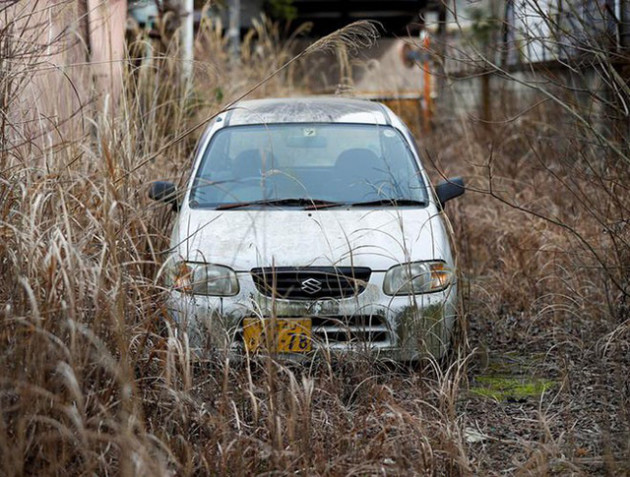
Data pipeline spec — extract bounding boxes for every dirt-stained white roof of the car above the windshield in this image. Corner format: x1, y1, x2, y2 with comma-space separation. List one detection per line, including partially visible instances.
225, 96, 392, 126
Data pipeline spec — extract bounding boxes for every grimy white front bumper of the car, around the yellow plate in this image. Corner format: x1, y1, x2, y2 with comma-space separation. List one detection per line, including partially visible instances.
169, 272, 457, 361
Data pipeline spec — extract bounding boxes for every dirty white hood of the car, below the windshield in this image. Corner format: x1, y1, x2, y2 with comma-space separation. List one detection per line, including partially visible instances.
172, 206, 451, 271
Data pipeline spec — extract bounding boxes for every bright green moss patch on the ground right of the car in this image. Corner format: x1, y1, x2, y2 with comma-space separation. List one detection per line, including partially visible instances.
470, 376, 556, 401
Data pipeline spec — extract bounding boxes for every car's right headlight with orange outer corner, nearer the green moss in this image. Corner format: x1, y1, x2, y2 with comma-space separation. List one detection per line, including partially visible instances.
383, 261, 453, 295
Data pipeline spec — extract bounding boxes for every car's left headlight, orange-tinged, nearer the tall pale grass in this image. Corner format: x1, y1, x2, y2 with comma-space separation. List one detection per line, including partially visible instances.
166, 262, 239, 296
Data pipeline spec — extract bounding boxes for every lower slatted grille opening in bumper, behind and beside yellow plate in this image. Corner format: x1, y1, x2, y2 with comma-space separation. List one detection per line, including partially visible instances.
234, 315, 389, 346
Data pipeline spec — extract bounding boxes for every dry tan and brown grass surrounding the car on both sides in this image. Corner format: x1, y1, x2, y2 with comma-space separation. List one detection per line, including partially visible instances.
0, 1, 630, 475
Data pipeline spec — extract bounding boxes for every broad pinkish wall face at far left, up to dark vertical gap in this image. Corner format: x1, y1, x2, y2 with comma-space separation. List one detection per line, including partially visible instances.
0, 0, 91, 155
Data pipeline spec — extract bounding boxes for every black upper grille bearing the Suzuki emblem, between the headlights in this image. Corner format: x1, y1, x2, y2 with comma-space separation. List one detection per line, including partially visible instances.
251, 267, 372, 300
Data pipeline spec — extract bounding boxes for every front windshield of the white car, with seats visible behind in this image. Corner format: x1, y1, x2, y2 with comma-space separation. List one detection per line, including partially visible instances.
190, 123, 427, 209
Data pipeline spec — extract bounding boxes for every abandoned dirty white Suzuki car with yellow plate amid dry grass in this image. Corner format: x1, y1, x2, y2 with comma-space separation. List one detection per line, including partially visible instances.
149, 97, 464, 361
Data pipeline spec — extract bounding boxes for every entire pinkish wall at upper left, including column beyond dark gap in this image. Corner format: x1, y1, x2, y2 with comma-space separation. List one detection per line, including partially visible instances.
0, 0, 127, 157
